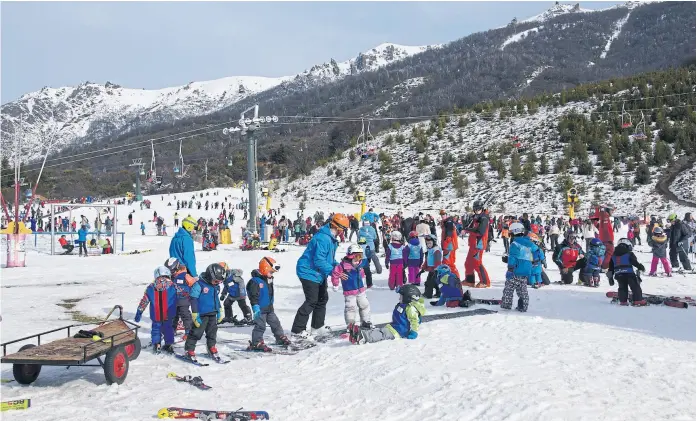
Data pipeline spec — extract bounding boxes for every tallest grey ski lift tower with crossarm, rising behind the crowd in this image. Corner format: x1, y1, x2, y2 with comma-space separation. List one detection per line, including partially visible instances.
223, 105, 278, 233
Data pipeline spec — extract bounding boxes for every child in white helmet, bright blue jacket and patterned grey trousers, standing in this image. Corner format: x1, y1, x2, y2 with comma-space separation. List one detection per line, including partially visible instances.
501, 222, 539, 312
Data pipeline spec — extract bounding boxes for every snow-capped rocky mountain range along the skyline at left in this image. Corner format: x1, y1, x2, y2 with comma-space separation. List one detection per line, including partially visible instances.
0, 43, 439, 160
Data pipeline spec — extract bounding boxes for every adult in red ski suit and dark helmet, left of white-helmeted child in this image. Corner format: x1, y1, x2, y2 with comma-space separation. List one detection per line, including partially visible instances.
463, 200, 491, 288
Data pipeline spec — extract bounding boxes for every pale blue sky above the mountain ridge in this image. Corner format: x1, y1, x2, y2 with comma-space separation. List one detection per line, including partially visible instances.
0, 1, 619, 104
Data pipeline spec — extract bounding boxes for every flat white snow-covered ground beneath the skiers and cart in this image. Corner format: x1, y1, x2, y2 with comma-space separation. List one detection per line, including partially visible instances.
0, 189, 696, 421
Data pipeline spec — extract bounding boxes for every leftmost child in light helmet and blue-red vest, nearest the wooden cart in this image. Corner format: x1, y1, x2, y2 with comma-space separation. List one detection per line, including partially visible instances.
135, 266, 177, 354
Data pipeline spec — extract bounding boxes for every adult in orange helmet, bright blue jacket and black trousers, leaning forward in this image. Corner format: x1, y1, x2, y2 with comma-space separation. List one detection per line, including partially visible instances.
291, 213, 349, 338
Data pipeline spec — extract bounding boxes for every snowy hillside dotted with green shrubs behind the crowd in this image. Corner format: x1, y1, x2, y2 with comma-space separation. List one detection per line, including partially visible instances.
281, 102, 694, 215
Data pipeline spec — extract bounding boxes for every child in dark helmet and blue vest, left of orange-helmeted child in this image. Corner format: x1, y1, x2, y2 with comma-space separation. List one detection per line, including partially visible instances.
184, 263, 227, 362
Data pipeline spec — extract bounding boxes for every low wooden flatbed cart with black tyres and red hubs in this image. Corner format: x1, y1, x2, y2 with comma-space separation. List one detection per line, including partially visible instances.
0, 305, 141, 384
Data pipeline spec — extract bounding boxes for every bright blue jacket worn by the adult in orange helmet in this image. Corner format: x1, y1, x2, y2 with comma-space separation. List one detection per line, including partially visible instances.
295, 225, 339, 284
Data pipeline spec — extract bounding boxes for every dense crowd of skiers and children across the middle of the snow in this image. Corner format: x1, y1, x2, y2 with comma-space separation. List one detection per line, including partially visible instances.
136, 195, 695, 361
